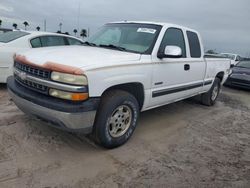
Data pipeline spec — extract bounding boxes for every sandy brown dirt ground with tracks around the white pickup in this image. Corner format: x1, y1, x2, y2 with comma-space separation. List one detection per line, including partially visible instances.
0, 85, 250, 188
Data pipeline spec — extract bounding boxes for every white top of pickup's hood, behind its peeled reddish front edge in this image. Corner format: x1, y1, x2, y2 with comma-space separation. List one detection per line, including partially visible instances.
17, 46, 141, 71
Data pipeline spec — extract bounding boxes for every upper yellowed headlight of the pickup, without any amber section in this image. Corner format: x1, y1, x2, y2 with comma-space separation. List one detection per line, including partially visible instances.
51, 72, 88, 85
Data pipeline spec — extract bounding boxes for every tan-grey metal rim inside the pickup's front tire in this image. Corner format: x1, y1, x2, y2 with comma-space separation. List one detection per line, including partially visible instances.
108, 105, 132, 138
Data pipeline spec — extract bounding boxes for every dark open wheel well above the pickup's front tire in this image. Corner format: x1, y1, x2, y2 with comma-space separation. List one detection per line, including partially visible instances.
102, 83, 144, 109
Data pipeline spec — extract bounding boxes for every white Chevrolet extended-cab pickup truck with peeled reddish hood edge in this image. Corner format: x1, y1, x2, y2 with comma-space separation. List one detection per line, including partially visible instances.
7, 22, 230, 148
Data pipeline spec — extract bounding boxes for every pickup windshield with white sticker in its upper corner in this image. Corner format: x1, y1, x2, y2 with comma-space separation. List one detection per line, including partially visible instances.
87, 23, 162, 54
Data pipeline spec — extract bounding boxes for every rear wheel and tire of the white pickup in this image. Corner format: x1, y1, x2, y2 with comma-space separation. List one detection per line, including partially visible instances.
201, 78, 221, 106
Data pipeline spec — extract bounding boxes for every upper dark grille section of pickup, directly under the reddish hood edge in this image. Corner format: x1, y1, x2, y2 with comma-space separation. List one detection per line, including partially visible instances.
14, 62, 50, 79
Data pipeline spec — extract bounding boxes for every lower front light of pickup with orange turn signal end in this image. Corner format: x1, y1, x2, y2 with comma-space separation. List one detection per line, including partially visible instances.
49, 89, 89, 101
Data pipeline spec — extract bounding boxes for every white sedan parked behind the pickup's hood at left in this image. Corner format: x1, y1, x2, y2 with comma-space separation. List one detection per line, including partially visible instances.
0, 31, 83, 83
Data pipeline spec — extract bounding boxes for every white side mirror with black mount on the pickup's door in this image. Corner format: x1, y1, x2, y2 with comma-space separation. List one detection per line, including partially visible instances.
157, 46, 182, 59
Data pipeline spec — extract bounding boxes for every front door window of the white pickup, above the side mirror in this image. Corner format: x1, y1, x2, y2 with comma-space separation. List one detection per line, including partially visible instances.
160, 28, 186, 58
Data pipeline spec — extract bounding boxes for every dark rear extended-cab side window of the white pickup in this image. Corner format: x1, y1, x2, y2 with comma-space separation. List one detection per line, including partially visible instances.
187, 31, 201, 58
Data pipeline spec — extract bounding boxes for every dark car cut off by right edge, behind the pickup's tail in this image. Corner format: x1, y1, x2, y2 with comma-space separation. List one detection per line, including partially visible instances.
225, 60, 250, 89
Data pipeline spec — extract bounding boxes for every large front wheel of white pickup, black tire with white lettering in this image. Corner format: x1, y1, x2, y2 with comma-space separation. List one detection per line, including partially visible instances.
93, 90, 139, 149
